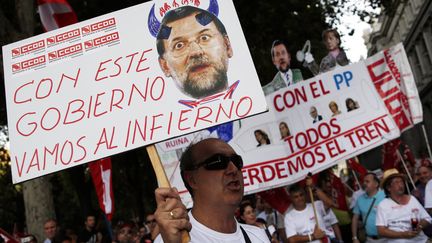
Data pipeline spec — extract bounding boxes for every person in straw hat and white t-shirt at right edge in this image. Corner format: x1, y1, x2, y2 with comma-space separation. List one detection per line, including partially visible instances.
376, 168, 432, 243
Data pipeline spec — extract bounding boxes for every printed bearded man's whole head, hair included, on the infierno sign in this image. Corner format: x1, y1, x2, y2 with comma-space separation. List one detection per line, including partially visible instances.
156, 1, 233, 99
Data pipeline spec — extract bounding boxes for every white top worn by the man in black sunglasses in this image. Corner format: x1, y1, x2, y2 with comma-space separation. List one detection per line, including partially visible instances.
154, 212, 270, 243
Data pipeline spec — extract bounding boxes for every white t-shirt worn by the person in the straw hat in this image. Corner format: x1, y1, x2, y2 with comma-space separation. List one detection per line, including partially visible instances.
376, 196, 431, 243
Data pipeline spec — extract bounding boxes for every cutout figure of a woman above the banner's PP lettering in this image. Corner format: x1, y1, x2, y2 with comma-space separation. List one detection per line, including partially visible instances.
304, 29, 350, 76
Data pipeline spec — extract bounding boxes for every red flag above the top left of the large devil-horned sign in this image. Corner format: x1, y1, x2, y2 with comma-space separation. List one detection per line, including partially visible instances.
37, 0, 78, 31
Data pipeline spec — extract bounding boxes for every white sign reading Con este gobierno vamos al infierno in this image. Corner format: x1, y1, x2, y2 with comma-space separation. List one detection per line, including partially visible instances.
3, 0, 267, 183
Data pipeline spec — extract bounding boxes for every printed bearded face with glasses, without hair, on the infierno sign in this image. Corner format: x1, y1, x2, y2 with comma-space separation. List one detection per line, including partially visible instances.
159, 13, 233, 98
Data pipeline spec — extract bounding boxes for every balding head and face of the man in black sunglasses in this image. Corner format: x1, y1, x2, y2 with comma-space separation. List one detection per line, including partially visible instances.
186, 139, 243, 208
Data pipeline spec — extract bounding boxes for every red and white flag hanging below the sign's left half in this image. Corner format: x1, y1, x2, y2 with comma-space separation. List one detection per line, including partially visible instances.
88, 157, 114, 221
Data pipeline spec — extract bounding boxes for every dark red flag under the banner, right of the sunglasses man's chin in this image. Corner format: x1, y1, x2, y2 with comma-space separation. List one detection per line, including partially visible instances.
258, 187, 291, 214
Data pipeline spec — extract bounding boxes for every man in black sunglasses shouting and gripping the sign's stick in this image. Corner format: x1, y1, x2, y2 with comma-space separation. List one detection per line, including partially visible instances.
155, 138, 269, 243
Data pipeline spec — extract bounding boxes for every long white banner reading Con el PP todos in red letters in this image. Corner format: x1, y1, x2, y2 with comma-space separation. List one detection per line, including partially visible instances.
157, 45, 422, 206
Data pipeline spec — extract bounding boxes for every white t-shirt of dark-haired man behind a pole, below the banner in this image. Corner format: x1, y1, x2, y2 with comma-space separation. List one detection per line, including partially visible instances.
285, 201, 334, 243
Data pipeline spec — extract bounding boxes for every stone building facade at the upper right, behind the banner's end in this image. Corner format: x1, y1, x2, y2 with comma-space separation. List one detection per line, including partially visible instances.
367, 0, 432, 163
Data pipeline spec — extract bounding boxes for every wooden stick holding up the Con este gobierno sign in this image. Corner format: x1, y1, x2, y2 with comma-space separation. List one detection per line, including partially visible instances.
146, 144, 190, 243
